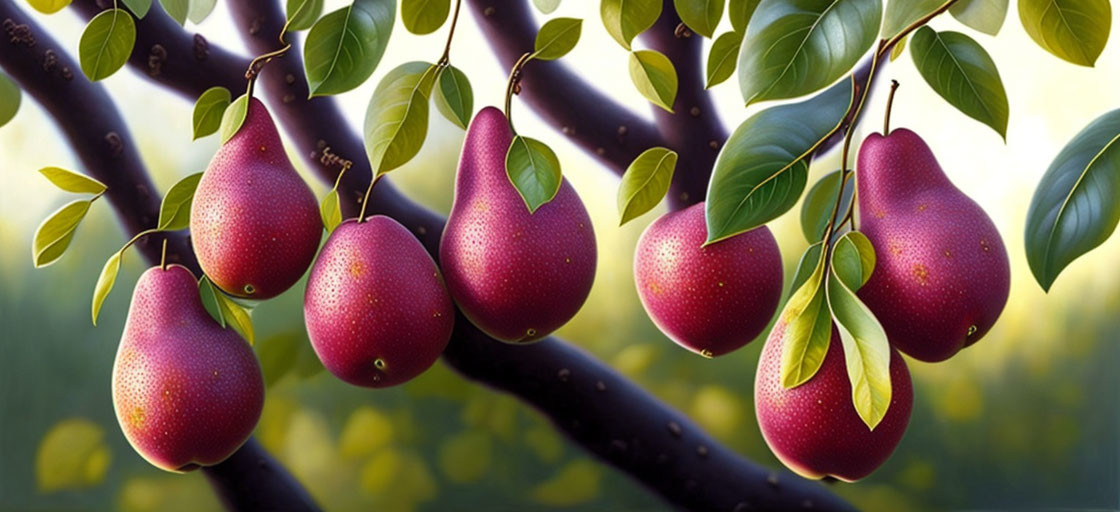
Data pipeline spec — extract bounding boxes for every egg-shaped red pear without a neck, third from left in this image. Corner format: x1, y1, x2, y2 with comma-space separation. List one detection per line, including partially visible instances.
304, 215, 455, 388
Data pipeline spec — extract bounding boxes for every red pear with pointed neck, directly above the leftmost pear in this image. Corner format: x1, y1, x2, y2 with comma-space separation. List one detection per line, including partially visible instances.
190, 97, 323, 300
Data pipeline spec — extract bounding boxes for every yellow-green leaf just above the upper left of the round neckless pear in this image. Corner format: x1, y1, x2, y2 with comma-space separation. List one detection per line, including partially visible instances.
618, 148, 676, 225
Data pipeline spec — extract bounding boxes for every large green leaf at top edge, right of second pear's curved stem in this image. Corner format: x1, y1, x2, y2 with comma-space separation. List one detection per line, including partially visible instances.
304, 0, 396, 97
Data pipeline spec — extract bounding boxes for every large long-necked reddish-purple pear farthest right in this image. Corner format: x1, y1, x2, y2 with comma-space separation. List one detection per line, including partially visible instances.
858, 129, 1010, 362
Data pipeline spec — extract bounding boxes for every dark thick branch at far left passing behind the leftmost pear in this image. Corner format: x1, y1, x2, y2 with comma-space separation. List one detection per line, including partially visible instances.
0, 0, 318, 511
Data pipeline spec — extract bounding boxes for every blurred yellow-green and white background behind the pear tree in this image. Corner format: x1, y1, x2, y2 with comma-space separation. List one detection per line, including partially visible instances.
0, 0, 1120, 511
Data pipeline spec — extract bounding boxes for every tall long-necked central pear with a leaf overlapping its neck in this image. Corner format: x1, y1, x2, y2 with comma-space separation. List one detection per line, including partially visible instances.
439, 106, 596, 343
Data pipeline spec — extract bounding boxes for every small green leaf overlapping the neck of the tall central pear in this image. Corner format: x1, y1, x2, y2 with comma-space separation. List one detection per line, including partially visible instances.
505, 136, 562, 213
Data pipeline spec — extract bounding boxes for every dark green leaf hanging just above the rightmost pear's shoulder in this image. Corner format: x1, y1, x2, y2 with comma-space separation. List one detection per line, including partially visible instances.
911, 27, 1010, 140
